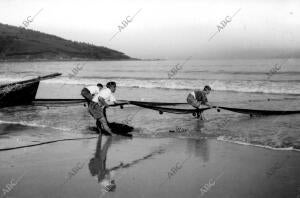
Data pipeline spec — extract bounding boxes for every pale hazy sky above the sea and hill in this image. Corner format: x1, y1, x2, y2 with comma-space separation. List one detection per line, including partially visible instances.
0, 0, 300, 59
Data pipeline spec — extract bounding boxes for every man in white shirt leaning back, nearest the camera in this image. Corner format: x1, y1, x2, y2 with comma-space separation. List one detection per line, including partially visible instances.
89, 82, 117, 135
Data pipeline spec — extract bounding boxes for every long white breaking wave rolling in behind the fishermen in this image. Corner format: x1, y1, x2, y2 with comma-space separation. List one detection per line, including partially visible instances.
45, 78, 300, 95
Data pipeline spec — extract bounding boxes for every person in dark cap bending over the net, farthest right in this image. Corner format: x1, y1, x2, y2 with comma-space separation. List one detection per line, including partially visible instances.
186, 85, 211, 120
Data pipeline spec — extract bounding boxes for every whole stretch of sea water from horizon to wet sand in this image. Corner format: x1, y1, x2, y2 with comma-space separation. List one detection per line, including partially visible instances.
0, 60, 300, 149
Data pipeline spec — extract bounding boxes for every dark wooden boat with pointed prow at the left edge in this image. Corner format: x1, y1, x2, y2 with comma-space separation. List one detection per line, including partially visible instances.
0, 73, 61, 108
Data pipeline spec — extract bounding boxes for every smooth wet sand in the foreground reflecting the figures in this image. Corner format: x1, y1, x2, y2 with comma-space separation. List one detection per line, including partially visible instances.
0, 136, 300, 198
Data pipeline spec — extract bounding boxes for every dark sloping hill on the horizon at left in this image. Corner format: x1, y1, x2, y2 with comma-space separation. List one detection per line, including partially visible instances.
0, 23, 132, 61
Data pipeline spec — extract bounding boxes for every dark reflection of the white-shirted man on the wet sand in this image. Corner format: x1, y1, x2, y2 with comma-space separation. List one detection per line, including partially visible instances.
89, 134, 116, 191
